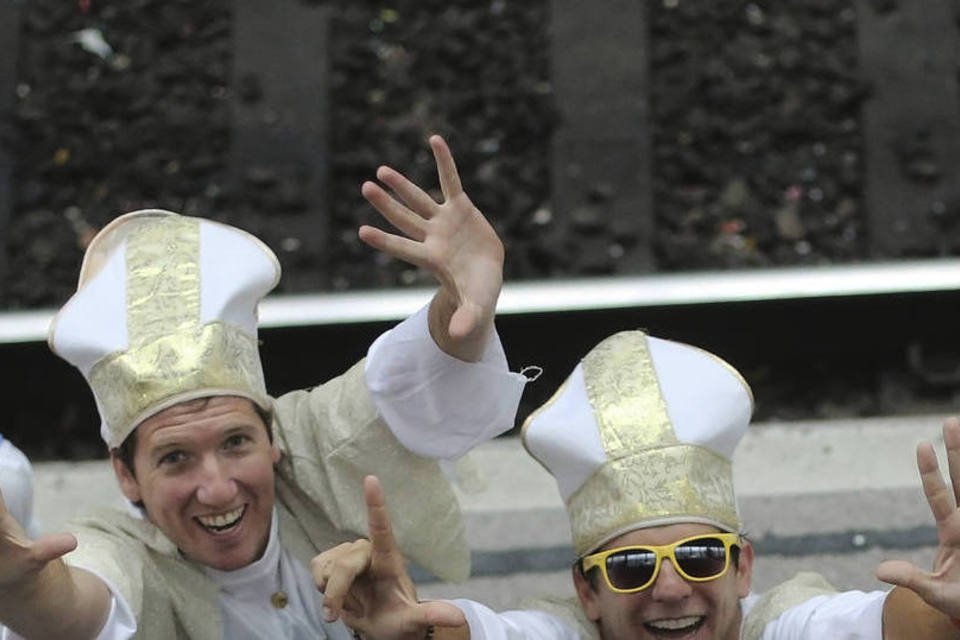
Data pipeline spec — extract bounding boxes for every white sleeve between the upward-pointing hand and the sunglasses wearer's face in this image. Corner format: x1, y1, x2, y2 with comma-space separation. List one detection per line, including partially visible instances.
450, 600, 580, 640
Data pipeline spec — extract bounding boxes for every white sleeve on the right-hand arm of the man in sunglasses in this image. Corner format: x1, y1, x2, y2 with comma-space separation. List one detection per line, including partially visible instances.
760, 591, 888, 640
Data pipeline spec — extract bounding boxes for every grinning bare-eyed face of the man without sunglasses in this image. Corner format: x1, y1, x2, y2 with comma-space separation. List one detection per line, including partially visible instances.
114, 396, 280, 571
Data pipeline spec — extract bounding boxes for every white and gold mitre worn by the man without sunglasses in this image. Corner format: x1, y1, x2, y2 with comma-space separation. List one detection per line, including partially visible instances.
49, 209, 280, 448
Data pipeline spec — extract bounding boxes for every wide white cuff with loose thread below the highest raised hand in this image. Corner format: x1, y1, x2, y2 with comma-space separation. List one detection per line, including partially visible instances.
364, 305, 527, 459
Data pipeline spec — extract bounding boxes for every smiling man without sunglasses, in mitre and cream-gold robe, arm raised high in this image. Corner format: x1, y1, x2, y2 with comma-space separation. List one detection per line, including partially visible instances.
0, 136, 525, 640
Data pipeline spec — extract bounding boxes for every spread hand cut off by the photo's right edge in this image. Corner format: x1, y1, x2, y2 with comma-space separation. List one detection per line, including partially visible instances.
877, 418, 960, 618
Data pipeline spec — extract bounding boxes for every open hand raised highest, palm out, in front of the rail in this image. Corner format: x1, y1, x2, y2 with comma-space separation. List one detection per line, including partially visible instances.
359, 135, 504, 360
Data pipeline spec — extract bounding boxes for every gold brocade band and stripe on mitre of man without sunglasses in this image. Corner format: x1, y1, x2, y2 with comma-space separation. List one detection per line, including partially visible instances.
88, 217, 268, 447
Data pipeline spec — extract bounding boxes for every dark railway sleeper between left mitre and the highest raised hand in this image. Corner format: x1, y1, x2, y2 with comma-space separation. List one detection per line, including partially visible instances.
230, 0, 329, 289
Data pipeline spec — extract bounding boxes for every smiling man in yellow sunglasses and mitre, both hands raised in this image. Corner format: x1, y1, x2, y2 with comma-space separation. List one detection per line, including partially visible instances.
313, 331, 960, 640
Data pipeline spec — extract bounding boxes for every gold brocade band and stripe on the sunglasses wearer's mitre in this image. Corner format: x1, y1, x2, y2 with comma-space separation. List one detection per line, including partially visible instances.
567, 331, 740, 556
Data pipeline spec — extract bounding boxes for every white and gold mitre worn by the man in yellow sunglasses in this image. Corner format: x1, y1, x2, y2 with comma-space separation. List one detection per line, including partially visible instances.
523, 331, 753, 556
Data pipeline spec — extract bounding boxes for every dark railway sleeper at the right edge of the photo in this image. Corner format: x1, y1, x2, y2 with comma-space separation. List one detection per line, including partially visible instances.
856, 0, 960, 257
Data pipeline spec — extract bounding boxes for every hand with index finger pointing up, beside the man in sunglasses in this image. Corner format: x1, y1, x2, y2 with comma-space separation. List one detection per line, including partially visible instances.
310, 476, 467, 640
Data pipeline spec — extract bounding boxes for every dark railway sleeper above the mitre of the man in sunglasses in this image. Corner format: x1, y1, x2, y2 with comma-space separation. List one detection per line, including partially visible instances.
551, 0, 653, 273
